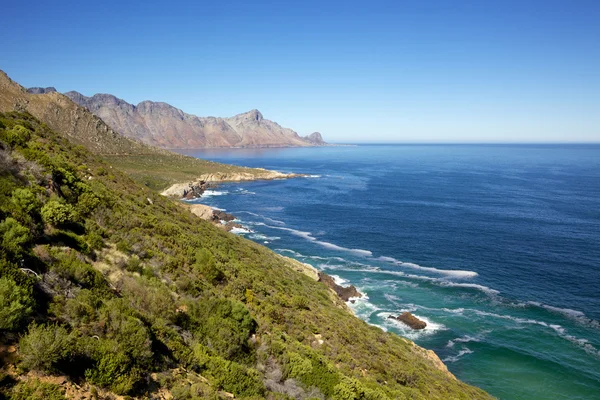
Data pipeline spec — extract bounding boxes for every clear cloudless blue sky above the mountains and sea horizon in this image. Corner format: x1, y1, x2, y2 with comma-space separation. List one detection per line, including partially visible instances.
0, 0, 600, 142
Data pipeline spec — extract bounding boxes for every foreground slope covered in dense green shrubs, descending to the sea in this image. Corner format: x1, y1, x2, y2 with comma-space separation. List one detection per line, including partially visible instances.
0, 113, 488, 399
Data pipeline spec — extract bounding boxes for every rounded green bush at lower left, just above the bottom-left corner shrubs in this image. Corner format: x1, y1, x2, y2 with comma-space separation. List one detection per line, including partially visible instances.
19, 324, 72, 372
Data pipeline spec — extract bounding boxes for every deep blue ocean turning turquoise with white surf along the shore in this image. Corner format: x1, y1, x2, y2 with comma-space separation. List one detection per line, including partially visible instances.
176, 145, 600, 400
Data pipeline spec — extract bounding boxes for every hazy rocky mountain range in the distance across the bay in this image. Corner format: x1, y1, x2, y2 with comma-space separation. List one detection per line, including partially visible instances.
65, 91, 324, 149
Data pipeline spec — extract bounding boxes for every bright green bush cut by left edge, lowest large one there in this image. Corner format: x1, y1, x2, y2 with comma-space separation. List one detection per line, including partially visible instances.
0, 276, 34, 330
